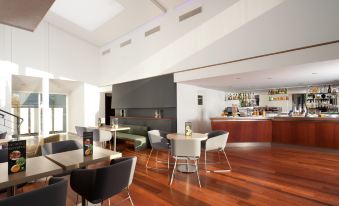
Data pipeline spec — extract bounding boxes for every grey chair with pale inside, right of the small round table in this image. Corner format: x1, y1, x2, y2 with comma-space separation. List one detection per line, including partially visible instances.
201, 130, 232, 172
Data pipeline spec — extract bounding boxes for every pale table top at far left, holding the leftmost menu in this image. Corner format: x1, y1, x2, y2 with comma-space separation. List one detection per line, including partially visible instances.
0, 156, 63, 189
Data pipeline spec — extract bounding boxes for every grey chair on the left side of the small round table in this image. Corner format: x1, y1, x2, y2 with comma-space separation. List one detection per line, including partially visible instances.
146, 130, 170, 169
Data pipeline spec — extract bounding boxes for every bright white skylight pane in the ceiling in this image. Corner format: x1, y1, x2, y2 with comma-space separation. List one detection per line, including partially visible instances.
51, 0, 124, 31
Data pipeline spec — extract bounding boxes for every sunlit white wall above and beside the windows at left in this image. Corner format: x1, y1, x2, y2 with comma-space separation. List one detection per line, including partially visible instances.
0, 22, 100, 135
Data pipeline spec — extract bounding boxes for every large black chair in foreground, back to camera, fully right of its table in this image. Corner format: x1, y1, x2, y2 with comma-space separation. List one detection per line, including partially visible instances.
70, 157, 137, 205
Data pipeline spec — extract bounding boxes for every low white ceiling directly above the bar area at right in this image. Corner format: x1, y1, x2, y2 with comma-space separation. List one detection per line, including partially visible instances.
181, 60, 339, 91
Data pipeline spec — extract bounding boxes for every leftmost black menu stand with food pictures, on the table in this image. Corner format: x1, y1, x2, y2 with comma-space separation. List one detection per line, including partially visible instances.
8, 140, 26, 174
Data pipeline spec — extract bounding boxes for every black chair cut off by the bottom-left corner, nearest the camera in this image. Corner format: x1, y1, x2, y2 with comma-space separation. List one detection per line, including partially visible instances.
0, 178, 68, 206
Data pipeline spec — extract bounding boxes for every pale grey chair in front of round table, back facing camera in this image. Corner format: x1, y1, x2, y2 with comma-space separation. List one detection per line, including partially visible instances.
170, 138, 201, 187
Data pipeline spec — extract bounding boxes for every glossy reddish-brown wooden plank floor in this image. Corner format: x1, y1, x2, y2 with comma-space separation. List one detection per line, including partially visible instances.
0, 145, 339, 206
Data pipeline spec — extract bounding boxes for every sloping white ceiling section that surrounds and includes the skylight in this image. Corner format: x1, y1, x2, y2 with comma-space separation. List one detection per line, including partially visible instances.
45, 0, 185, 46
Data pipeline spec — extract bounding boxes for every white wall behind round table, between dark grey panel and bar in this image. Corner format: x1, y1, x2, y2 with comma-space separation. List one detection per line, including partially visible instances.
177, 83, 225, 133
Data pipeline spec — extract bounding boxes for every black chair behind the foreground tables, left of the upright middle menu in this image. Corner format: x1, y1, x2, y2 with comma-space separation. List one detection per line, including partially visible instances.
41, 140, 82, 156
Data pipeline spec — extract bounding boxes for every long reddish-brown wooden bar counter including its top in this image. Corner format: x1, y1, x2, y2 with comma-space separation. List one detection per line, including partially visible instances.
211, 117, 339, 149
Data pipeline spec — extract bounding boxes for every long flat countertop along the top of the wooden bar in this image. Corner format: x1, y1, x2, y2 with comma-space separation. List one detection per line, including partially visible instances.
210, 116, 339, 122
